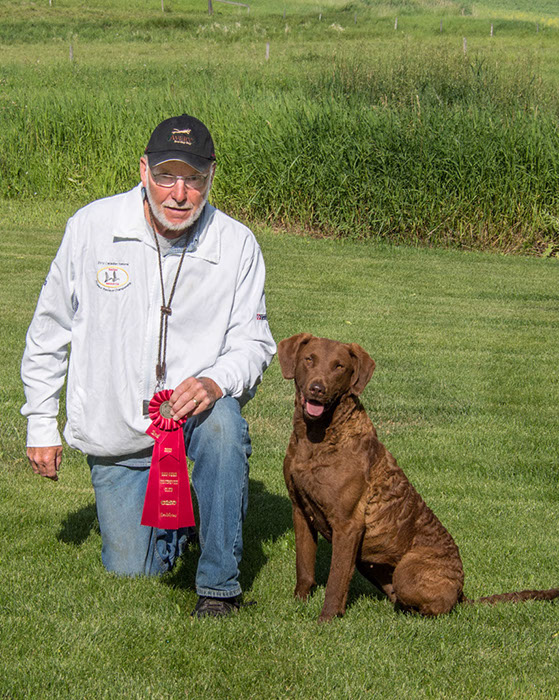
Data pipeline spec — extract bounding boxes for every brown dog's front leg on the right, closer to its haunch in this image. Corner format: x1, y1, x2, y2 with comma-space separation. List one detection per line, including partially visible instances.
318, 526, 363, 622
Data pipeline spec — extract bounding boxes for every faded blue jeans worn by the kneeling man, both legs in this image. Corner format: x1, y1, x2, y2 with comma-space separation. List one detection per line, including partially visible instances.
88, 396, 251, 598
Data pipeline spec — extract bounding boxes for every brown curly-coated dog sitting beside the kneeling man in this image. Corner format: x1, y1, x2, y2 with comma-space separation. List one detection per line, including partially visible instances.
278, 333, 559, 620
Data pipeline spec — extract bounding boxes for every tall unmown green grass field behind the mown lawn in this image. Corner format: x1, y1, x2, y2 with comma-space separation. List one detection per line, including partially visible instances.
0, 0, 559, 253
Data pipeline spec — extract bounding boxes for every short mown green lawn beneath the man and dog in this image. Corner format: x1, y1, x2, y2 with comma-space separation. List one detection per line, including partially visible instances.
0, 203, 559, 700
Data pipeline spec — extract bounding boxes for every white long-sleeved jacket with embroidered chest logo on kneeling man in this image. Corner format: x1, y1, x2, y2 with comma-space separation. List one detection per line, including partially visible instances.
21, 185, 276, 456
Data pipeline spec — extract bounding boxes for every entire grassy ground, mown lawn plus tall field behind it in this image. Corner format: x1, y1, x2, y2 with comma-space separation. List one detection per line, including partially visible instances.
0, 0, 559, 700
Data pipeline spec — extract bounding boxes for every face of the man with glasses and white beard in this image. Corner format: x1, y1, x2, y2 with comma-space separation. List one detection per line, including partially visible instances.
140, 156, 213, 238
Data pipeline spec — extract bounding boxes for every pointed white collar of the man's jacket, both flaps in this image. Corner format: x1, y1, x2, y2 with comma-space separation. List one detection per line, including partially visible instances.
113, 183, 221, 264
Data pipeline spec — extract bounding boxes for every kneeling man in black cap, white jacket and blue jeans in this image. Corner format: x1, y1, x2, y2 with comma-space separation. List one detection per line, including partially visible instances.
22, 114, 275, 617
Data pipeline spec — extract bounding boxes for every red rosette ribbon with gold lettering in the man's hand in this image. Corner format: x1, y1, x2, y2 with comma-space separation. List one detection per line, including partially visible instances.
141, 389, 194, 530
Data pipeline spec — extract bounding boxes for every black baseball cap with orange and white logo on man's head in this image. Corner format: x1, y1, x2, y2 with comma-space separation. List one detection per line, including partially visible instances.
145, 114, 215, 172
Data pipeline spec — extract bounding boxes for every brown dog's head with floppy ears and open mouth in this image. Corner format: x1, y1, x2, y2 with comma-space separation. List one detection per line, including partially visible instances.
278, 333, 375, 420
